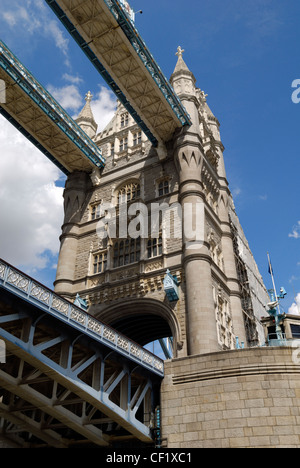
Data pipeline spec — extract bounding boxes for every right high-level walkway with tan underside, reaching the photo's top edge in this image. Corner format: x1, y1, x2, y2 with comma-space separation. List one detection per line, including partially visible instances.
45, 0, 191, 150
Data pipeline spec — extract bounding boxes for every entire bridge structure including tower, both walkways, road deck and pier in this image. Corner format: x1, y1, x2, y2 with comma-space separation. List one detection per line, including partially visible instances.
0, 0, 300, 448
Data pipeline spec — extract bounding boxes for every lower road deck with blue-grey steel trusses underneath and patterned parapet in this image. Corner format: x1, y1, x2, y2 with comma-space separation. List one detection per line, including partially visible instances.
0, 260, 164, 447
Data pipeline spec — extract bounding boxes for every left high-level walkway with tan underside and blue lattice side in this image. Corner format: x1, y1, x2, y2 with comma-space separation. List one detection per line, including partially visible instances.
0, 40, 105, 175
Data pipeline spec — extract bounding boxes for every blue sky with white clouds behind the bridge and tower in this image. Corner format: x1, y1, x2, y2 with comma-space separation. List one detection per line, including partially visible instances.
0, 0, 300, 311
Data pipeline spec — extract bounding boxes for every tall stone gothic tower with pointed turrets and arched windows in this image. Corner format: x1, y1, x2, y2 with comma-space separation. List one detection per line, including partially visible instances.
55, 47, 267, 357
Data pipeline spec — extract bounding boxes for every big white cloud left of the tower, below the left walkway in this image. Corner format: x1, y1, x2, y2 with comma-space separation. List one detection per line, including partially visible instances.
0, 117, 63, 272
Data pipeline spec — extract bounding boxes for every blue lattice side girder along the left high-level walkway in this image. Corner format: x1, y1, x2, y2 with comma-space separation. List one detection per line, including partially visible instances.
0, 40, 105, 168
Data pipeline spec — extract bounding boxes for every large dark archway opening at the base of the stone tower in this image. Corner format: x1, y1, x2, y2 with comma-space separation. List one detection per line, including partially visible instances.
97, 298, 181, 357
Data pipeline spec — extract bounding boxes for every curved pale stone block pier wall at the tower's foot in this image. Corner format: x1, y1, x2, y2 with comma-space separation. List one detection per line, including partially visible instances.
161, 348, 300, 448
